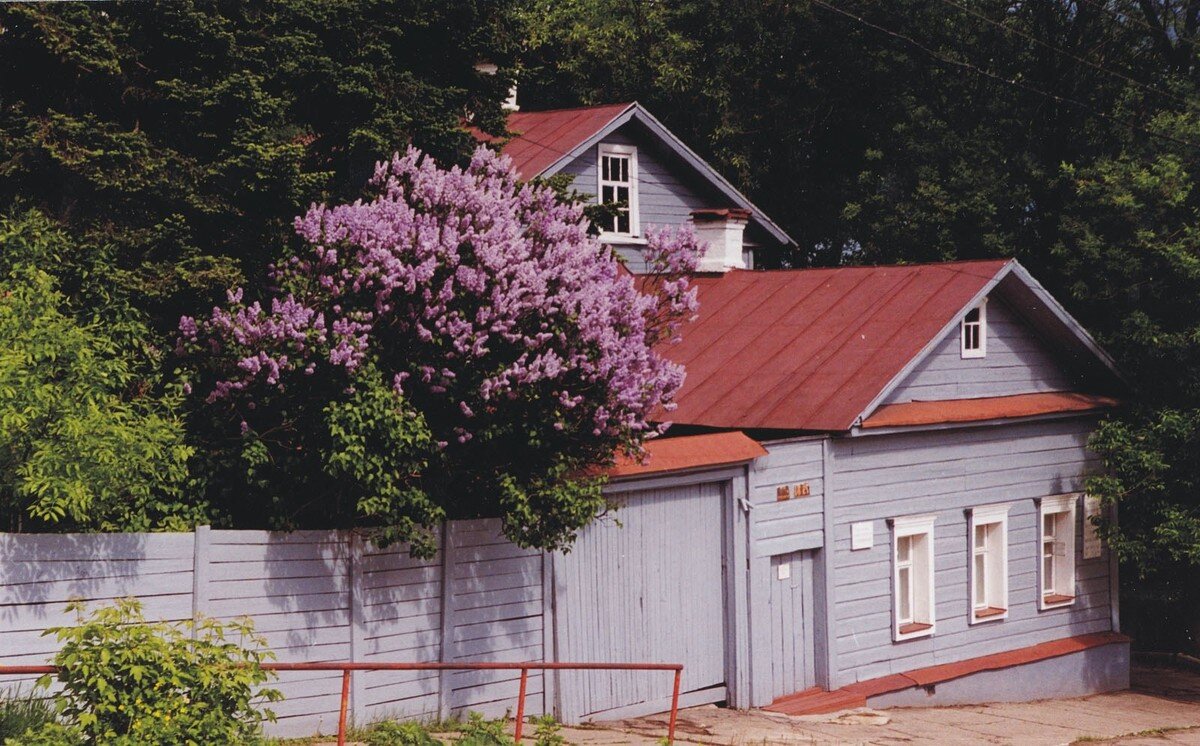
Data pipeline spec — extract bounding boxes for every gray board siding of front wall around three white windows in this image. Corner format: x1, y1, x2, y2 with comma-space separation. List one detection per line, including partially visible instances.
830, 419, 1111, 686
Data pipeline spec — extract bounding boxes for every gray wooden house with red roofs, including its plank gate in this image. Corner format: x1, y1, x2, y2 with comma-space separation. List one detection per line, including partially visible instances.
482, 103, 1129, 720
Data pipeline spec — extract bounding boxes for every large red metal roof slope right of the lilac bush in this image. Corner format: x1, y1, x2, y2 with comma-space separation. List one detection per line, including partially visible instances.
664, 260, 1007, 431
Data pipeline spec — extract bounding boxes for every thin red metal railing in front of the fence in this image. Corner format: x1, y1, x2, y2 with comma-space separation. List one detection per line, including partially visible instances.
0, 661, 683, 746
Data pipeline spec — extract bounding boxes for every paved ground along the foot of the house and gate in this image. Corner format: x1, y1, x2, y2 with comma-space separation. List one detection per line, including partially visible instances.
563, 668, 1200, 746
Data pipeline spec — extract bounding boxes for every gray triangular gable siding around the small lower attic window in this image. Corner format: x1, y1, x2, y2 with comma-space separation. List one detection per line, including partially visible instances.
884, 296, 1078, 404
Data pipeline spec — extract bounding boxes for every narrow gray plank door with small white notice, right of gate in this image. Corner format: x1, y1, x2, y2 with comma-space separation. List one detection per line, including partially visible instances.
768, 552, 816, 699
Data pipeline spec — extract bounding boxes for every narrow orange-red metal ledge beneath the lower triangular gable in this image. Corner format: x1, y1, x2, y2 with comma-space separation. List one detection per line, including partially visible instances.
863, 391, 1117, 428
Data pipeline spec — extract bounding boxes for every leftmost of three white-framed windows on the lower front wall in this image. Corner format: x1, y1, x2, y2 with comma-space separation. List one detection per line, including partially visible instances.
890, 516, 937, 643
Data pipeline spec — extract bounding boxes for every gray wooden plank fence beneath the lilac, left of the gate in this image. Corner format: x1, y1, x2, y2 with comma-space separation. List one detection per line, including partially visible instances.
0, 521, 545, 736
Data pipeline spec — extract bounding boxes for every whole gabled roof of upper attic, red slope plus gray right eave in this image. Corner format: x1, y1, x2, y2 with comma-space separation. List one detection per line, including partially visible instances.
472, 101, 796, 245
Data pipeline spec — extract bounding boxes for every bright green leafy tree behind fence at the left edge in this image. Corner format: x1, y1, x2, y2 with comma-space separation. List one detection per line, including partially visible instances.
0, 212, 194, 530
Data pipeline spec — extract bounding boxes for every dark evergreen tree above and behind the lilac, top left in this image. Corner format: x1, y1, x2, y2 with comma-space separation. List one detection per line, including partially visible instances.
0, 0, 520, 330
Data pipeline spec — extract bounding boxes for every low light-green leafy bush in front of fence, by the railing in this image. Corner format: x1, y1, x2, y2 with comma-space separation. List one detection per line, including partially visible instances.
15, 598, 282, 746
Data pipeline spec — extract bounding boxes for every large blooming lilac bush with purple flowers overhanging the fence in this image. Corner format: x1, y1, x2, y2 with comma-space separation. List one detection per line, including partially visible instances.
180, 148, 700, 551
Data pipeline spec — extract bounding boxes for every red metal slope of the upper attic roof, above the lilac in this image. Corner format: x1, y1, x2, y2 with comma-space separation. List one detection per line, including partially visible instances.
472, 103, 634, 179
